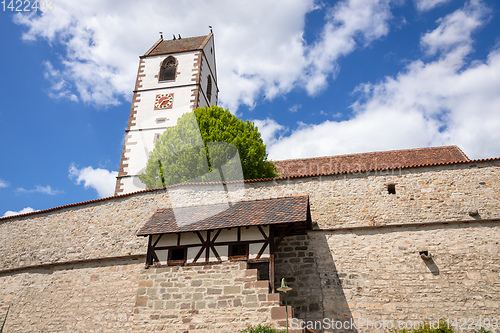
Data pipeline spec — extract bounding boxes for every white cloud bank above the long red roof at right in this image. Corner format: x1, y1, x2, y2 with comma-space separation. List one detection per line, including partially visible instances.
268, 1, 500, 159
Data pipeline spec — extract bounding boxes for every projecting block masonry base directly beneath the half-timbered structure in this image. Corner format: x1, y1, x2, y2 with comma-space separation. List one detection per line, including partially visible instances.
134, 262, 293, 333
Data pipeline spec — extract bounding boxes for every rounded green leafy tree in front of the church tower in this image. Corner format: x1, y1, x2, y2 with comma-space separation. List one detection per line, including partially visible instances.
139, 106, 278, 188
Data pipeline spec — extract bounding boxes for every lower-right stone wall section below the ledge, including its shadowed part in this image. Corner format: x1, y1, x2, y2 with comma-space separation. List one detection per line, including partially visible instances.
276, 222, 500, 332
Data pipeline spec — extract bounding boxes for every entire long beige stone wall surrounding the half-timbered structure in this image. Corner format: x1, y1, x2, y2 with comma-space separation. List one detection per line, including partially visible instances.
0, 161, 500, 332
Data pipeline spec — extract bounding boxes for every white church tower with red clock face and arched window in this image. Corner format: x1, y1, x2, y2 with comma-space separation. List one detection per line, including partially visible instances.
115, 33, 219, 195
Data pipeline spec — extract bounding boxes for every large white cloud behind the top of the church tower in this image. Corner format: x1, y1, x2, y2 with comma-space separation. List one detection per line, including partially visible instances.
14, 0, 391, 112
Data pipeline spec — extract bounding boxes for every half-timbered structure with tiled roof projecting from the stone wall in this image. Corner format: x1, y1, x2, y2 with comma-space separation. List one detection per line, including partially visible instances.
138, 195, 311, 290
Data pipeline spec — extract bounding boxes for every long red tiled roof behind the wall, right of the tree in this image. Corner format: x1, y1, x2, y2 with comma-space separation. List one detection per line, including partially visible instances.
274, 146, 470, 178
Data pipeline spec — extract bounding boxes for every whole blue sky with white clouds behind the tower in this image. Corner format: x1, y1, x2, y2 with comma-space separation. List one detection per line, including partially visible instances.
0, 0, 500, 217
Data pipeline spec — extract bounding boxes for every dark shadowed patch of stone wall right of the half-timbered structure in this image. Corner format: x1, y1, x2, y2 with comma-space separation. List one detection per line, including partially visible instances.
274, 234, 357, 332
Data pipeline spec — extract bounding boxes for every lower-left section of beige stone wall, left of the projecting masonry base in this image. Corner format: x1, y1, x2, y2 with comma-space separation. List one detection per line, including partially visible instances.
0, 255, 144, 333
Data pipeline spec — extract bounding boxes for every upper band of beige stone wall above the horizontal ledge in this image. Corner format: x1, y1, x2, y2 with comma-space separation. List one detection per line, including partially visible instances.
0, 161, 500, 271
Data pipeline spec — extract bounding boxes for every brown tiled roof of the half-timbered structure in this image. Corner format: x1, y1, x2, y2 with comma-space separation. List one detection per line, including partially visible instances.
137, 195, 309, 236
